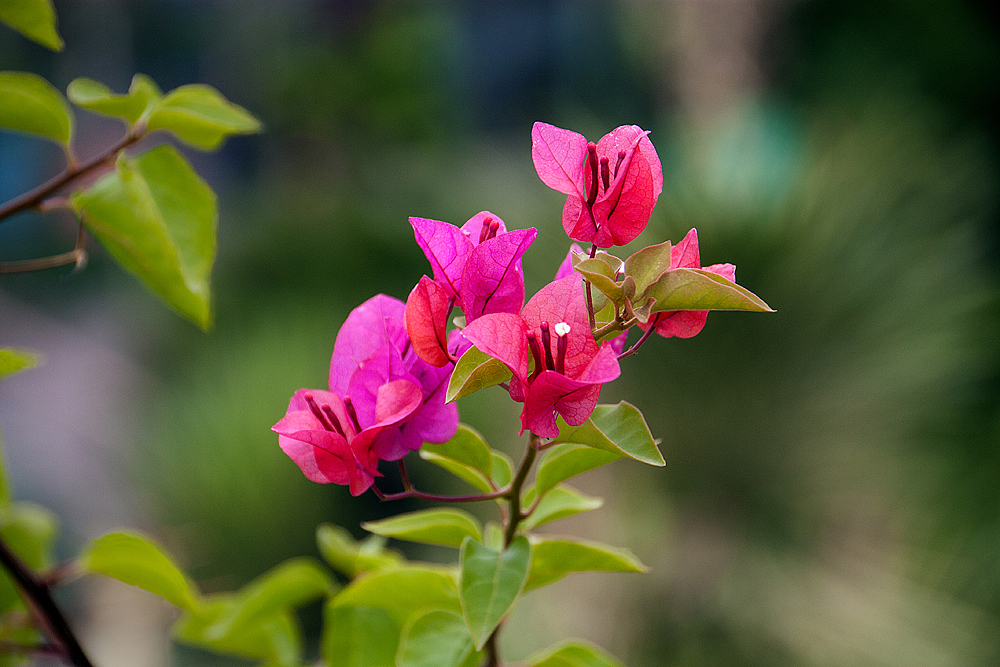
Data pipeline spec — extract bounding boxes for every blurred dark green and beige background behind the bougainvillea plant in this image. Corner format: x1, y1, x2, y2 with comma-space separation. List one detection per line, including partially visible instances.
0, 0, 1000, 667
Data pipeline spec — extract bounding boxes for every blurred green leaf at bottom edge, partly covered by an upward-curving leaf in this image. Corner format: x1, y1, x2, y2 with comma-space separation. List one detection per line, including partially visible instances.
173, 594, 302, 667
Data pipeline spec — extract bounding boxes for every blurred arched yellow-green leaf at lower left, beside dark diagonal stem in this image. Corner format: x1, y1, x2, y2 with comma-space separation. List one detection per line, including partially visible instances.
78, 533, 198, 612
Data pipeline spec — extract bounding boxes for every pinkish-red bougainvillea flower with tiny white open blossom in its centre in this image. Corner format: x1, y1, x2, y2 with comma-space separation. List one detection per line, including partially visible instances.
462, 274, 620, 438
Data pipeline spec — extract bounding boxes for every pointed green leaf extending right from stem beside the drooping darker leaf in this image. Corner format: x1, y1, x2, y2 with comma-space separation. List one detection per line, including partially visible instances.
524, 536, 648, 591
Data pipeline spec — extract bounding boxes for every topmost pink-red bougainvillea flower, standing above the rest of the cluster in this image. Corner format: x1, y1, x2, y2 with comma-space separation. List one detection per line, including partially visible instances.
531, 123, 663, 248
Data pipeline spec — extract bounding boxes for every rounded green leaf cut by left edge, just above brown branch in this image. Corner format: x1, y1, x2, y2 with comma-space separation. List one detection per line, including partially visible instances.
0, 72, 73, 149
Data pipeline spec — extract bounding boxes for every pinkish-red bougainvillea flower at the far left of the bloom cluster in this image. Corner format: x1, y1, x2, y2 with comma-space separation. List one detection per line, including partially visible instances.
272, 381, 423, 496
